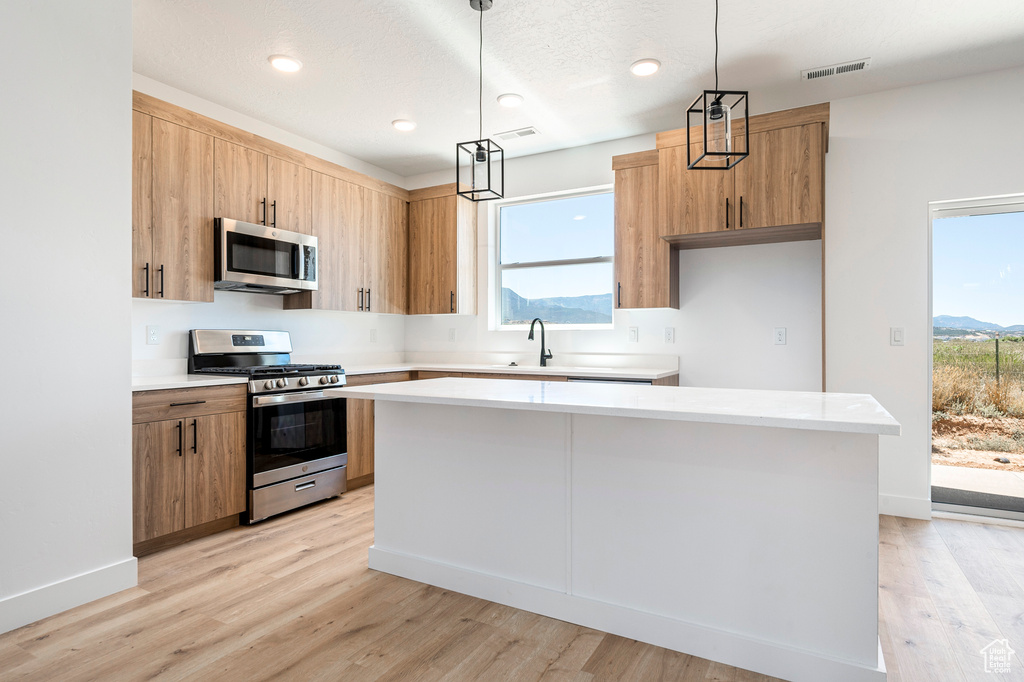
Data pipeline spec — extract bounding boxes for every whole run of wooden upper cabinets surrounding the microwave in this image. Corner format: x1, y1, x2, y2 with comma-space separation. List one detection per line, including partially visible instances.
132, 92, 407, 313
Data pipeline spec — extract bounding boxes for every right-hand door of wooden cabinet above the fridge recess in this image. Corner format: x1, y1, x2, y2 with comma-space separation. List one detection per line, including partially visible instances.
733, 124, 824, 228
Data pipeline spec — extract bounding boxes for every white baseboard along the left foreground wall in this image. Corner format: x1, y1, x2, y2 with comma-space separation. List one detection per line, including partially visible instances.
0, 557, 138, 633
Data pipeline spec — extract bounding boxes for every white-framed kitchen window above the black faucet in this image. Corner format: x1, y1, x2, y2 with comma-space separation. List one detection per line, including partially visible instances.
495, 187, 614, 328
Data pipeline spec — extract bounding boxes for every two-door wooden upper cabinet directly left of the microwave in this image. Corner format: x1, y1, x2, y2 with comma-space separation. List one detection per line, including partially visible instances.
132, 112, 214, 301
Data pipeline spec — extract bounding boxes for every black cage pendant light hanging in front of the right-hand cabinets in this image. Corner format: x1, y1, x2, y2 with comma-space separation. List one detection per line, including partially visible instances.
686, 0, 751, 170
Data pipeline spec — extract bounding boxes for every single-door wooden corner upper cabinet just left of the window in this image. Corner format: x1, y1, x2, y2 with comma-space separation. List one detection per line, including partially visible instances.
409, 182, 476, 314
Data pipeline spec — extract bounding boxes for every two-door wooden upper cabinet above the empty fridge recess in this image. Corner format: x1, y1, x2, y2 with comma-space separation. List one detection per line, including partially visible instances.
657, 99, 828, 240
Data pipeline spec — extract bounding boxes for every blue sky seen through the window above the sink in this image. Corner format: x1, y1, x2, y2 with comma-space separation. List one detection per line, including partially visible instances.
501, 191, 614, 298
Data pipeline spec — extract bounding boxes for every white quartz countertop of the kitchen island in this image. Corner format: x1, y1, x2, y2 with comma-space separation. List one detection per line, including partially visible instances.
325, 378, 900, 435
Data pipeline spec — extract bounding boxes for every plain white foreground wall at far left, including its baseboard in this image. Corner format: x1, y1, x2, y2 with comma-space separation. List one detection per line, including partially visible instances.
0, 0, 136, 632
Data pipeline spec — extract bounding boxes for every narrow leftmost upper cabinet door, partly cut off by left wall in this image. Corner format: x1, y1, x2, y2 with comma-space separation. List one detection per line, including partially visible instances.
131, 112, 154, 298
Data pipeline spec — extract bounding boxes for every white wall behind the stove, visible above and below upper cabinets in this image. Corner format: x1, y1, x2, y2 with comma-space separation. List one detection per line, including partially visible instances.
131, 74, 404, 368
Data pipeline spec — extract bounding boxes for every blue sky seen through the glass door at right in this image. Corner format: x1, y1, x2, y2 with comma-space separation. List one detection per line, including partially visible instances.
932, 213, 1024, 327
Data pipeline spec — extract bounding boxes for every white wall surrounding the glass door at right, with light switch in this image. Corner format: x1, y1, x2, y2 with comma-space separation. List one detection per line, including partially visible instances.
825, 69, 1024, 517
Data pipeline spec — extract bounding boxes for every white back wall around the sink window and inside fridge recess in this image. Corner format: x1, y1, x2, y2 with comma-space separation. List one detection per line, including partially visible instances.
406, 135, 821, 390
